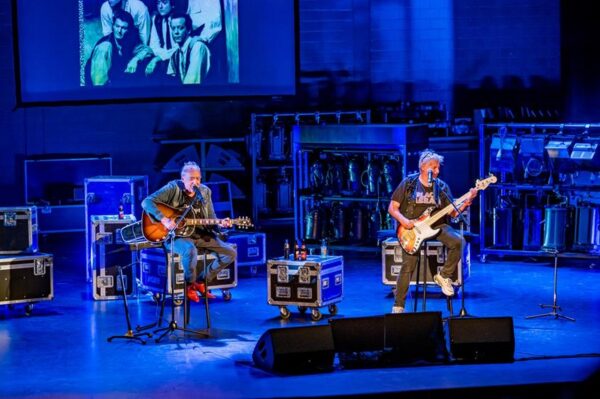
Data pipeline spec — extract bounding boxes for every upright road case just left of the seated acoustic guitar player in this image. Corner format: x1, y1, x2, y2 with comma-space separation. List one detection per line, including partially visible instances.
88, 215, 137, 300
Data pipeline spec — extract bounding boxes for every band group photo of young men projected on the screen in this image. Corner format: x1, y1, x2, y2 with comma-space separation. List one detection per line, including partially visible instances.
79, 0, 240, 88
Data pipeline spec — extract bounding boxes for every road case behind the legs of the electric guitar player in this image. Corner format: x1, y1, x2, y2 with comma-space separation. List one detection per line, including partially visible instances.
381, 238, 471, 286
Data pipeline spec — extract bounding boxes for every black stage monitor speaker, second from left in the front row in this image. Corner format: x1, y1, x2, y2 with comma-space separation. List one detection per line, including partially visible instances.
329, 316, 384, 368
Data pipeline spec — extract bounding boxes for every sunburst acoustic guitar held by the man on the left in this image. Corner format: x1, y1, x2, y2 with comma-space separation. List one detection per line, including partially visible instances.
142, 204, 252, 242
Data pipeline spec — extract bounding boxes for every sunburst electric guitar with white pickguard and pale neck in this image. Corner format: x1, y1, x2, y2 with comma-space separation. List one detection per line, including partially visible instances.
396, 175, 497, 255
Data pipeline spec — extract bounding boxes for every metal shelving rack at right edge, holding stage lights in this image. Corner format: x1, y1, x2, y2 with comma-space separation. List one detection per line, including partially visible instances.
479, 123, 600, 262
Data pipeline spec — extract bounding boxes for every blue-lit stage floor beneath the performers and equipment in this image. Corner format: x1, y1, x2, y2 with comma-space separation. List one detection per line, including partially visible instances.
0, 239, 600, 398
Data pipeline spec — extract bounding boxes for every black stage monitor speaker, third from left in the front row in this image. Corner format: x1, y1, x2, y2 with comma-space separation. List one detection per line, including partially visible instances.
384, 312, 448, 364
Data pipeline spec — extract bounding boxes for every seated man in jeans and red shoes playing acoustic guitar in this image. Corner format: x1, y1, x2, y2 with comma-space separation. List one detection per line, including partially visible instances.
142, 162, 237, 302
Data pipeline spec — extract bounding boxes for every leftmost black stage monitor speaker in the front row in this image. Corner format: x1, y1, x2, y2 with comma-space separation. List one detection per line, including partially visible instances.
252, 325, 335, 374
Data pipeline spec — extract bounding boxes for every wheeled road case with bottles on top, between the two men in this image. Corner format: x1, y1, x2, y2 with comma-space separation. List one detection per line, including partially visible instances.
267, 255, 344, 320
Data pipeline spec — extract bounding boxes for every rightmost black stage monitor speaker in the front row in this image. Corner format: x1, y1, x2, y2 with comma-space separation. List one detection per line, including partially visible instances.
448, 317, 515, 363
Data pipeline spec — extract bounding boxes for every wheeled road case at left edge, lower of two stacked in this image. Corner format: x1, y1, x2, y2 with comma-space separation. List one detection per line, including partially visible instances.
0, 252, 54, 314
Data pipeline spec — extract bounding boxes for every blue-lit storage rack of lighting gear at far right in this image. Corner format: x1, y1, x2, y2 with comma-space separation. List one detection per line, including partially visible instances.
479, 123, 600, 262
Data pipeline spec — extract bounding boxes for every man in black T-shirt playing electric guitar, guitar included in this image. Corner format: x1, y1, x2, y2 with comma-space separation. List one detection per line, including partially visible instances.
388, 150, 478, 313
